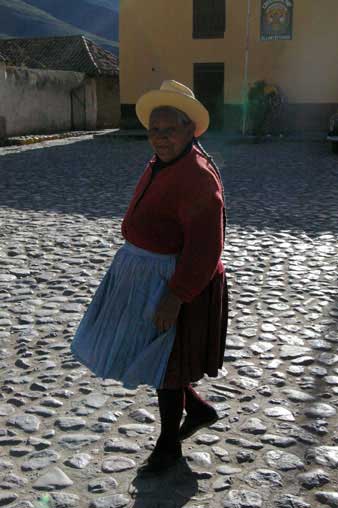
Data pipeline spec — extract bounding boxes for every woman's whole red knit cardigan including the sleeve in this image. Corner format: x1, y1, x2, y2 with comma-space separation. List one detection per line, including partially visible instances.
122, 145, 224, 302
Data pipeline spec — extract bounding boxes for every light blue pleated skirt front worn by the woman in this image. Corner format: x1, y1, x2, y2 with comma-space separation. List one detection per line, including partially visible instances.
71, 242, 177, 388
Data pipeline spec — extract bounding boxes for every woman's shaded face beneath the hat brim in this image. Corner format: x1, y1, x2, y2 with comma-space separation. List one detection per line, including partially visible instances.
148, 111, 195, 162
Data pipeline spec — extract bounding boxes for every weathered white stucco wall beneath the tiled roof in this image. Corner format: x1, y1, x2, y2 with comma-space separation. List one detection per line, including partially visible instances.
0, 64, 87, 136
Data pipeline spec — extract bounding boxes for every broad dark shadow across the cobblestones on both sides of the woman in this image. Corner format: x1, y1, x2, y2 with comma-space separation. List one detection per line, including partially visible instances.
0, 139, 338, 235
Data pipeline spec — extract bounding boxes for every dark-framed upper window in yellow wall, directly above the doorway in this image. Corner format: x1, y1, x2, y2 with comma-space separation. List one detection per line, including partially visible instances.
193, 0, 226, 39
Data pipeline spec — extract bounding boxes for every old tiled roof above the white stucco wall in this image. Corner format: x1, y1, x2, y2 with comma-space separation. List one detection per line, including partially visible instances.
0, 35, 119, 76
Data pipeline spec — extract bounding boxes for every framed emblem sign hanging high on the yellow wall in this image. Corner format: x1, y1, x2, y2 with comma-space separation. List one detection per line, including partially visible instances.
261, 0, 293, 41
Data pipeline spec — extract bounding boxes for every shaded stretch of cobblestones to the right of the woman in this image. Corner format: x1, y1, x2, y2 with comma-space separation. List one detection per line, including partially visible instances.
221, 143, 338, 236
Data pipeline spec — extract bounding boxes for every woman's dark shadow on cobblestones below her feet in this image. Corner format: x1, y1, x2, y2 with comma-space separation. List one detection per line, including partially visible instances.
129, 458, 198, 508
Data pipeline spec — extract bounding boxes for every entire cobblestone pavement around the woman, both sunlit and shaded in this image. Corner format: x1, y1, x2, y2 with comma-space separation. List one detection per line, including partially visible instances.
0, 138, 338, 508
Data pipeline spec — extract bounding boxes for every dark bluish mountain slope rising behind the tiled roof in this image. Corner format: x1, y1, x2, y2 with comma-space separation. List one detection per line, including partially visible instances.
0, 0, 118, 54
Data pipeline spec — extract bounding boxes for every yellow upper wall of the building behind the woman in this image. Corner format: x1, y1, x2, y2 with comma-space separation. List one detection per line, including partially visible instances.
120, 0, 338, 125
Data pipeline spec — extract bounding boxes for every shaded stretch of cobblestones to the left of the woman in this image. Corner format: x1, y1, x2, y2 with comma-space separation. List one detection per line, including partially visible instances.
0, 140, 150, 217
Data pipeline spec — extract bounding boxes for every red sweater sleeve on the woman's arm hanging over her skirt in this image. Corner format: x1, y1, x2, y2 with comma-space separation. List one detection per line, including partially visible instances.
168, 174, 224, 302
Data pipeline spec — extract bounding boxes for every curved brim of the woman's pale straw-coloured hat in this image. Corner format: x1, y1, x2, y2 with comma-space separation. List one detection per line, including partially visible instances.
136, 90, 210, 138
